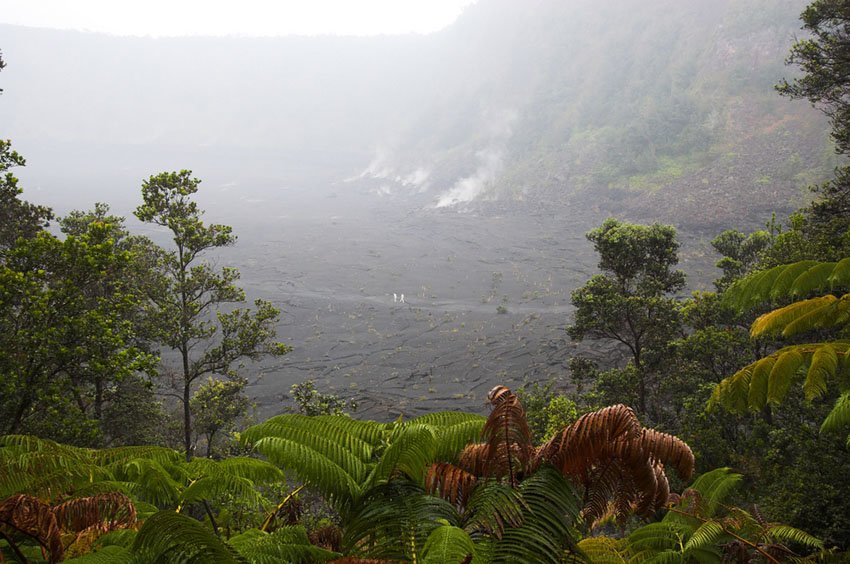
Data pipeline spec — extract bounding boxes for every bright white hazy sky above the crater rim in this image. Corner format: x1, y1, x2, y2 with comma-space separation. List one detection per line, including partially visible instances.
0, 0, 475, 36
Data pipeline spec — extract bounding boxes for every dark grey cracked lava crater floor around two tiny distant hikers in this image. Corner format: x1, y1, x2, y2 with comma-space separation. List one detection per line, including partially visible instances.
208, 185, 714, 420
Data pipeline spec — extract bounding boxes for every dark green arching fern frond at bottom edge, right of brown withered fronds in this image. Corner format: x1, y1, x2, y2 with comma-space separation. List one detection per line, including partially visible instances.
132, 511, 248, 564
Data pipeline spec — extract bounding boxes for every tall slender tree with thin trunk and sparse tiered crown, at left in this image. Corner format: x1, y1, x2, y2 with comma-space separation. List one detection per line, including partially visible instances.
135, 170, 289, 458
